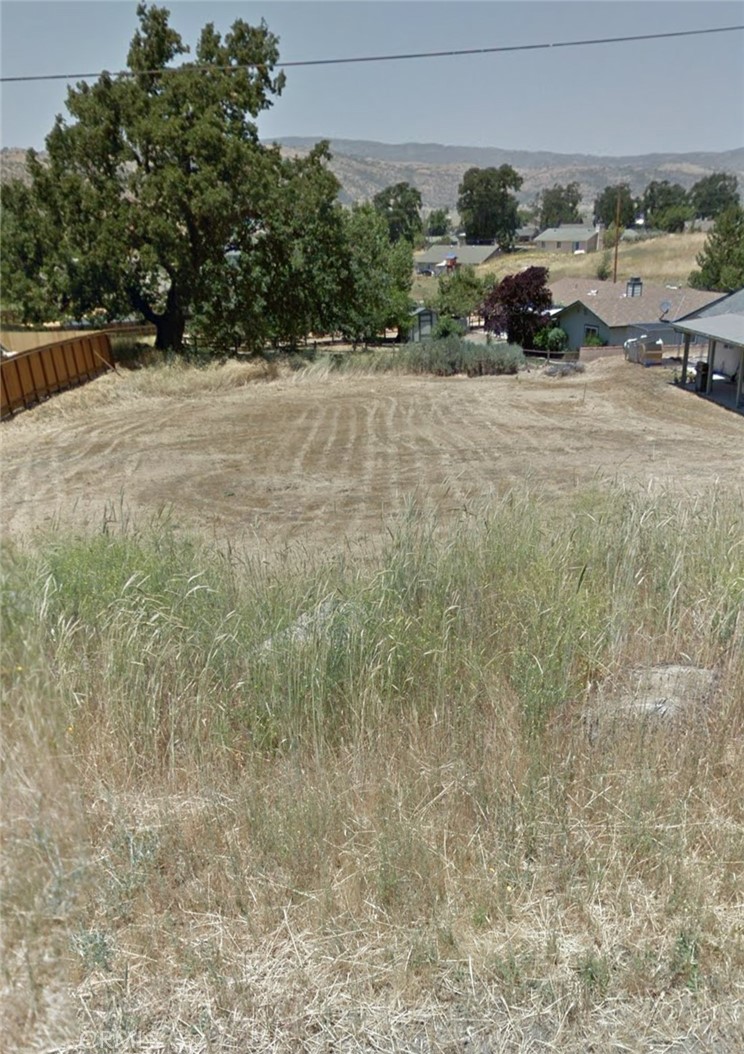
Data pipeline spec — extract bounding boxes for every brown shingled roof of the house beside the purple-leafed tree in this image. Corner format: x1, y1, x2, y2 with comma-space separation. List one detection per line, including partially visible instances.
550, 278, 720, 327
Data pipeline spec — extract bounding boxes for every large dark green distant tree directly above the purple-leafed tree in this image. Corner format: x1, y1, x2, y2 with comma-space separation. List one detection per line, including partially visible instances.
457, 164, 523, 252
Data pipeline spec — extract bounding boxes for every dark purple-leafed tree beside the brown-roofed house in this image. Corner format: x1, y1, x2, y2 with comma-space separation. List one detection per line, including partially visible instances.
483, 267, 553, 348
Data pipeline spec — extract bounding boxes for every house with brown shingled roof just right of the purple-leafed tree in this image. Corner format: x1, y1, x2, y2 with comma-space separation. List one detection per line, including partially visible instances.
550, 278, 720, 351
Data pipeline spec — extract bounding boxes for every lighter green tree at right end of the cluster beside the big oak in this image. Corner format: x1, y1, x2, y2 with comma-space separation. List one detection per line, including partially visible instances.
337, 204, 413, 344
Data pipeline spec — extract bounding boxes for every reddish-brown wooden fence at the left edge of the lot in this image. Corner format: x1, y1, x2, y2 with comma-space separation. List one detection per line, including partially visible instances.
0, 332, 114, 417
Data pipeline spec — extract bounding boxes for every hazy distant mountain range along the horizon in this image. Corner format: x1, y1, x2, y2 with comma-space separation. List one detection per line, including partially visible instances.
0, 136, 744, 210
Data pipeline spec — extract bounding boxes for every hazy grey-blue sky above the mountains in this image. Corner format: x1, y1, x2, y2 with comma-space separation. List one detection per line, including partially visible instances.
0, 0, 744, 155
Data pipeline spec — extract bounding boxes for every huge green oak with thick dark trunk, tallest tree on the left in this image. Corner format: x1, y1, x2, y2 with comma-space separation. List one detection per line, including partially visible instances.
3, 3, 320, 349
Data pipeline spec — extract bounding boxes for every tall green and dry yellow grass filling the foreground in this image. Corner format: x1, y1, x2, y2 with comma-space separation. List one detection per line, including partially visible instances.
2, 490, 744, 1052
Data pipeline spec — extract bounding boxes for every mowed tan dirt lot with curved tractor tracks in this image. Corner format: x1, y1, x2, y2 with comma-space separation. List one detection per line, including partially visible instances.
0, 358, 744, 553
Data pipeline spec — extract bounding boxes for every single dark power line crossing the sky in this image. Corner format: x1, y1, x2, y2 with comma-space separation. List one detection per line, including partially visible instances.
0, 25, 744, 83
